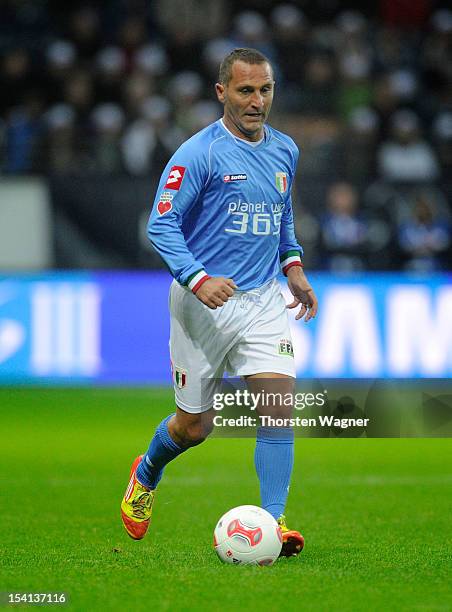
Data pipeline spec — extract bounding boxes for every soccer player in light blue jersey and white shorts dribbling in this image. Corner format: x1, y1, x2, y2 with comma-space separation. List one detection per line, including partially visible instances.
121, 49, 317, 556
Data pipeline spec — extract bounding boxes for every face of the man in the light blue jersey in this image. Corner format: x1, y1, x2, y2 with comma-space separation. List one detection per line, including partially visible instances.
216, 60, 275, 141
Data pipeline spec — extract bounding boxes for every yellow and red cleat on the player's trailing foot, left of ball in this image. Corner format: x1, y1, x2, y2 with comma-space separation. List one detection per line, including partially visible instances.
121, 455, 155, 540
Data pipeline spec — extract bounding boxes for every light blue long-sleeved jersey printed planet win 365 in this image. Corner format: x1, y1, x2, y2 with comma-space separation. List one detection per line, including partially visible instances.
148, 120, 303, 290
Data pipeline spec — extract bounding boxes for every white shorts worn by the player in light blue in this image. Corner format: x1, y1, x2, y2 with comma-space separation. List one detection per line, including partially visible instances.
169, 280, 295, 414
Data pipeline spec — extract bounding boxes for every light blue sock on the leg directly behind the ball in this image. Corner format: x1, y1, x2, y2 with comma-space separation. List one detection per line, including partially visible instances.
254, 427, 294, 519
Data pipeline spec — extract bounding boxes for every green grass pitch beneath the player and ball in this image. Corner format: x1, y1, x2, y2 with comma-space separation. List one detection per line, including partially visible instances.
0, 388, 452, 612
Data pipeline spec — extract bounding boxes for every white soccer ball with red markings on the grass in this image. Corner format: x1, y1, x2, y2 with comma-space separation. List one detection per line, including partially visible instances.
213, 506, 282, 565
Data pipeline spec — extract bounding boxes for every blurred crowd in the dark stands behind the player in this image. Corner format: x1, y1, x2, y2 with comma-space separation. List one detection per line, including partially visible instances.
0, 0, 452, 271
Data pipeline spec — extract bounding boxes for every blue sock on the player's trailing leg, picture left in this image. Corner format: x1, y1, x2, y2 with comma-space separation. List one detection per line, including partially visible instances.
137, 414, 187, 489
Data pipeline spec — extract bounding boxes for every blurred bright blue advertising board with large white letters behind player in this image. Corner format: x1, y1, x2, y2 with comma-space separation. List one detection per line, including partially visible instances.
0, 271, 452, 384
